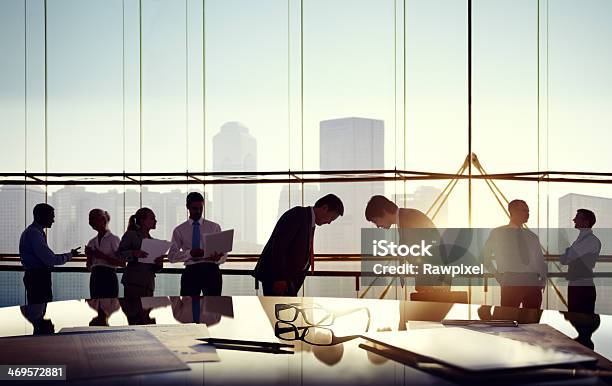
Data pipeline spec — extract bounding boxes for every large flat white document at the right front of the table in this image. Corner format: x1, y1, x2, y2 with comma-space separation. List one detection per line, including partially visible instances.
363, 327, 597, 371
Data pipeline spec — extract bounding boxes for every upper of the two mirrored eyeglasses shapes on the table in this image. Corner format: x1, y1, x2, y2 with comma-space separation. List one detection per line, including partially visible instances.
274, 303, 370, 330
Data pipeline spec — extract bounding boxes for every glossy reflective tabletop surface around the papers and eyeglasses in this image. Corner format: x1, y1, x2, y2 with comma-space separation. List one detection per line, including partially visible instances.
0, 296, 612, 384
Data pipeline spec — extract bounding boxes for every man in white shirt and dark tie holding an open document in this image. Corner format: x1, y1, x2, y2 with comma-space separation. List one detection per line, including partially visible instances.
168, 192, 227, 296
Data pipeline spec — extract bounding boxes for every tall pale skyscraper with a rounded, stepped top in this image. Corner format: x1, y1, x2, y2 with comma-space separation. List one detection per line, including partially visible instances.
211, 122, 257, 252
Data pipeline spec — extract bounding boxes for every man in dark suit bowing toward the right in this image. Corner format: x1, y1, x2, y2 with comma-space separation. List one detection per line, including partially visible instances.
253, 194, 344, 296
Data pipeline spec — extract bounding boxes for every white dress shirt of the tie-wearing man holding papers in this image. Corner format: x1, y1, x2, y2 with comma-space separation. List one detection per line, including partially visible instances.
168, 218, 227, 265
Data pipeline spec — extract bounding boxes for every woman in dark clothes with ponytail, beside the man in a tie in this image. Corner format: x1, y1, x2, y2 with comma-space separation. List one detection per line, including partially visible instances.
119, 208, 163, 298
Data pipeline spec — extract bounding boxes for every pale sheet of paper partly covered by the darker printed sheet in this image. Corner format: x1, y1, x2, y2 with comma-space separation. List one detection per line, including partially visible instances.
60, 323, 220, 362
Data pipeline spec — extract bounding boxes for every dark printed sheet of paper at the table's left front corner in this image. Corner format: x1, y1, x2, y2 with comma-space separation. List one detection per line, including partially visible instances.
0, 329, 189, 380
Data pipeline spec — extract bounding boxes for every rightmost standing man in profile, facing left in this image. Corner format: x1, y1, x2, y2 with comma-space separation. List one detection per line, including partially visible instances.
559, 209, 601, 314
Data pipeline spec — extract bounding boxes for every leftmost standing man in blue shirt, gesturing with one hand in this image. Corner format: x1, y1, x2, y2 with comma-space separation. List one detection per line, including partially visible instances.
19, 203, 79, 304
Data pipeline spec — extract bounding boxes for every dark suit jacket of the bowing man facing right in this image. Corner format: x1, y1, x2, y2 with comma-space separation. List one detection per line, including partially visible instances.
253, 206, 312, 281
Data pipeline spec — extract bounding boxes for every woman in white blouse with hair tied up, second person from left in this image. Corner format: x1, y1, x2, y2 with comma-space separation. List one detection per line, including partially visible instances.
85, 209, 125, 299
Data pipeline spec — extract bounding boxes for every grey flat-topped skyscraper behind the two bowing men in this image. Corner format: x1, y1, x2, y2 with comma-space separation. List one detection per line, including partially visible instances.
315, 117, 385, 253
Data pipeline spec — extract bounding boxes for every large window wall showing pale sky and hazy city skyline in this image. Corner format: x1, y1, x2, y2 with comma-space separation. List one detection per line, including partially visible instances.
0, 0, 612, 308
